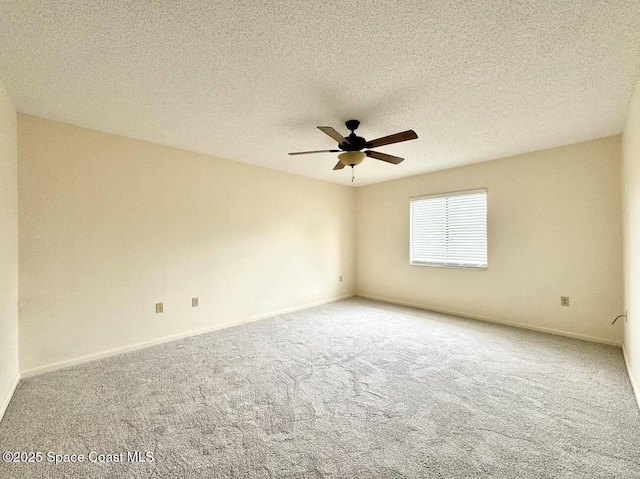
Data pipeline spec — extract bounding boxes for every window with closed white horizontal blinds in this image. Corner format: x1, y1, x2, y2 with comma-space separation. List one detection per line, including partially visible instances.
409, 189, 487, 269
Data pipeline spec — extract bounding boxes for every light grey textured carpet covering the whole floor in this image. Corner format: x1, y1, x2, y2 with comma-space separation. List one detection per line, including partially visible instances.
0, 298, 640, 479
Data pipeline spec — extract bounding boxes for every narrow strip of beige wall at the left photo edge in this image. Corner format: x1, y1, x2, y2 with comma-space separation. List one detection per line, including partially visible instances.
0, 83, 18, 419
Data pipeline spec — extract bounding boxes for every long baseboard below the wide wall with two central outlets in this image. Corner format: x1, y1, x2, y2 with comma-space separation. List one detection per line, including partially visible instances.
20, 294, 355, 378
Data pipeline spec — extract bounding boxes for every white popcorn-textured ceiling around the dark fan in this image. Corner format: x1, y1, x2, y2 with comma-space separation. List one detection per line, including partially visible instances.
0, 0, 640, 186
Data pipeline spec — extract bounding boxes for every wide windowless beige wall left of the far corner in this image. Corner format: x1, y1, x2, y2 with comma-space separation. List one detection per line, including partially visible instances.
18, 115, 355, 373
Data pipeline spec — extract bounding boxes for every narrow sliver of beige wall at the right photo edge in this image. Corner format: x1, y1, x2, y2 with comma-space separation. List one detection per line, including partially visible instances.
622, 77, 640, 404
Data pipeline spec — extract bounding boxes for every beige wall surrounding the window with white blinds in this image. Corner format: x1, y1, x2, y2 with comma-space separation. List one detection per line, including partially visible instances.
356, 137, 623, 344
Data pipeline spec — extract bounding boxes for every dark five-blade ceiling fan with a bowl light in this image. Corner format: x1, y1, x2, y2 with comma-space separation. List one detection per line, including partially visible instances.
289, 120, 418, 181
